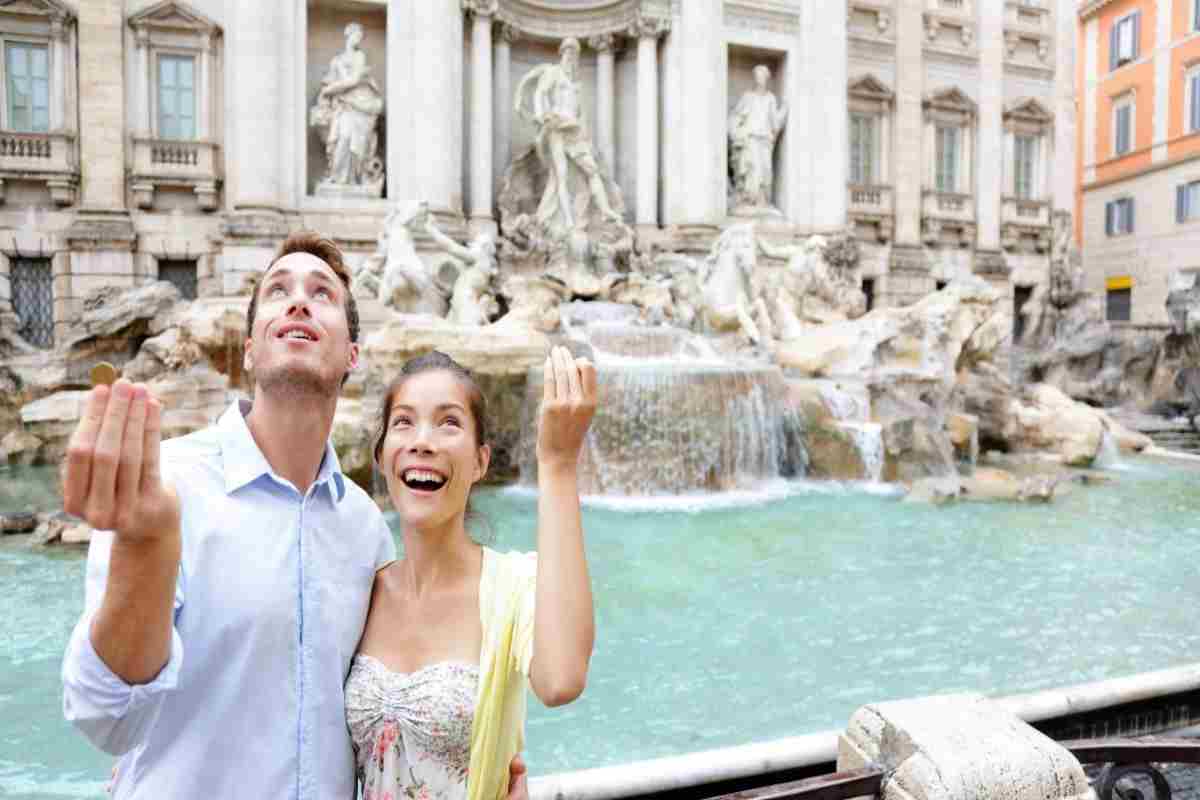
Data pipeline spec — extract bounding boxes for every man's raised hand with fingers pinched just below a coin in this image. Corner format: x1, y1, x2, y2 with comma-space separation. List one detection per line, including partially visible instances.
62, 379, 180, 541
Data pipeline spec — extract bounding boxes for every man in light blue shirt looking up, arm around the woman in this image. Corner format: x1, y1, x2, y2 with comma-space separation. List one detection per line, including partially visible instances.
62, 227, 528, 800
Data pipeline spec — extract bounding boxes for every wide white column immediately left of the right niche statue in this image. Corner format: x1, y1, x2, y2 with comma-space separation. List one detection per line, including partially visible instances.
662, 0, 728, 231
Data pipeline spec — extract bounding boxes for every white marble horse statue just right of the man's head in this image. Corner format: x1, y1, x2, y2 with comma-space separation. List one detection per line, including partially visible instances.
354, 203, 446, 317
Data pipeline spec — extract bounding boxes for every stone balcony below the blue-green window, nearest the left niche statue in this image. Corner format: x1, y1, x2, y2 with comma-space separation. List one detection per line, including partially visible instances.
130, 138, 221, 211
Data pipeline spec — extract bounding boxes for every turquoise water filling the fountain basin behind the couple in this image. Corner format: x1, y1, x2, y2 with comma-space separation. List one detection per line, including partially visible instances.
0, 462, 1200, 799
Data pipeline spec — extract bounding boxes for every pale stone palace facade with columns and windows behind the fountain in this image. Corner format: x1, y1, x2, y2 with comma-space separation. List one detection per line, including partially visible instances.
0, 0, 1075, 350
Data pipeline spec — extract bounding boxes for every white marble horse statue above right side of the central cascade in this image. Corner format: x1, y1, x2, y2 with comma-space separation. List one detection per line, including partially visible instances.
700, 223, 770, 345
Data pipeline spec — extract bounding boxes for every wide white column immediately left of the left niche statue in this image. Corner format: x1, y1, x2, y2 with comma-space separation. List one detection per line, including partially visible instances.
226, 2, 280, 213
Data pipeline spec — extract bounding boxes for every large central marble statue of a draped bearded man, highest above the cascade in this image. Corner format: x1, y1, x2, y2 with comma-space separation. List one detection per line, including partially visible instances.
515, 38, 620, 233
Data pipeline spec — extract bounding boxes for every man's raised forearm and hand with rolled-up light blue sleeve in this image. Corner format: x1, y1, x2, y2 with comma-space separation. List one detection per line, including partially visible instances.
62, 380, 182, 752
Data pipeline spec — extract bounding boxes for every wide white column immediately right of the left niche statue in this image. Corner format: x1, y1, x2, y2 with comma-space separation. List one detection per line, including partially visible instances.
388, 0, 463, 225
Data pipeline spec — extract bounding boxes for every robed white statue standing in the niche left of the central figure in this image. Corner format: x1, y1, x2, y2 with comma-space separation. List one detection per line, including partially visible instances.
308, 23, 384, 197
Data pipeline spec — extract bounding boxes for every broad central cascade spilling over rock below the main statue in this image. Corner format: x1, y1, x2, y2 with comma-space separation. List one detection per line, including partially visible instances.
518, 323, 808, 497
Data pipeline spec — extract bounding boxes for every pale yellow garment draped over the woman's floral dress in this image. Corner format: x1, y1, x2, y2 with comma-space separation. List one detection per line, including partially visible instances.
467, 547, 538, 800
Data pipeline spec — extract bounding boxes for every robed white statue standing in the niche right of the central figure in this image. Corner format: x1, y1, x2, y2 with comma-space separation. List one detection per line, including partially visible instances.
730, 64, 787, 213
